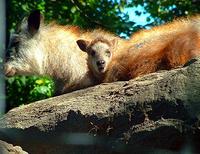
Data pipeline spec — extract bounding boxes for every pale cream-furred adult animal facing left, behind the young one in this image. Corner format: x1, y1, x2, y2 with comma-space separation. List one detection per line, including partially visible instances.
5, 11, 123, 94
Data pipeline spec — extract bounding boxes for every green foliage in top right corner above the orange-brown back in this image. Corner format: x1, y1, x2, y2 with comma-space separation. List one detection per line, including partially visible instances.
127, 0, 200, 26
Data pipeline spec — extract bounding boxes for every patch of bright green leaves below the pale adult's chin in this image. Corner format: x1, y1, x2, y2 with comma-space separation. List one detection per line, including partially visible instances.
6, 76, 54, 109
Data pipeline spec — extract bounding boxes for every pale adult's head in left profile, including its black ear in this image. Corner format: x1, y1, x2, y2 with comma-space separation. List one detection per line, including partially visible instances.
5, 11, 43, 76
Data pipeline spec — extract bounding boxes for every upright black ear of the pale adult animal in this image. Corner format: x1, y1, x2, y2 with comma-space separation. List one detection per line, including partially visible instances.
28, 10, 42, 35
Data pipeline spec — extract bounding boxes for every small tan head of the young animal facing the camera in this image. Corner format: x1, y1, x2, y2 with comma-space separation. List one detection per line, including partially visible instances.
77, 38, 116, 76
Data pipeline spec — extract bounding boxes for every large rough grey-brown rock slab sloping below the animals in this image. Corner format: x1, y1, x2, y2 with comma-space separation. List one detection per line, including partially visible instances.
0, 59, 200, 154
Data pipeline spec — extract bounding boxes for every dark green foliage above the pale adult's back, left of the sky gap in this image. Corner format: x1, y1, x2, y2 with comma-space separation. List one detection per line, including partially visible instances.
7, 0, 135, 35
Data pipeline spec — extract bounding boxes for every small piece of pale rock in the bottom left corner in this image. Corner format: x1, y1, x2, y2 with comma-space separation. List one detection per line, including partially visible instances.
0, 140, 28, 154
